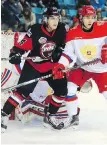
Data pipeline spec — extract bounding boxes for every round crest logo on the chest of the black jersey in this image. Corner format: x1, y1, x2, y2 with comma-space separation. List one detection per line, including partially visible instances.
40, 42, 56, 59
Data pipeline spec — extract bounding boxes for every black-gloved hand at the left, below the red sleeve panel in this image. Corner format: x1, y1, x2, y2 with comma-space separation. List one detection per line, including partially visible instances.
9, 52, 21, 64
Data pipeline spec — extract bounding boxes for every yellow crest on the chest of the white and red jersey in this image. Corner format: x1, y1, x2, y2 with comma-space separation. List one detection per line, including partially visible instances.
80, 44, 97, 60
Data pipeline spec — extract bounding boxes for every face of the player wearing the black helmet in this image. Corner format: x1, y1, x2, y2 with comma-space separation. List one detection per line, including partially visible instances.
48, 16, 59, 31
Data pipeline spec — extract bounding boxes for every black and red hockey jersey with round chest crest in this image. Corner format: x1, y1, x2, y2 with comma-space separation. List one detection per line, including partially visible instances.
13, 23, 66, 72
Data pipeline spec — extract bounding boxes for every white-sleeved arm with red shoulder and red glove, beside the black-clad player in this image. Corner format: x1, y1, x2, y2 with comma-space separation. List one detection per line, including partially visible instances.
52, 31, 76, 79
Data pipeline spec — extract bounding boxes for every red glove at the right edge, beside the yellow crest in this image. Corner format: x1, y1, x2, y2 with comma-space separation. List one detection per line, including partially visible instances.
101, 44, 107, 64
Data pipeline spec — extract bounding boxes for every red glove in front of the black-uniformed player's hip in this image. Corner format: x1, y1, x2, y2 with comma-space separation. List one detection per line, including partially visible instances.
52, 63, 65, 79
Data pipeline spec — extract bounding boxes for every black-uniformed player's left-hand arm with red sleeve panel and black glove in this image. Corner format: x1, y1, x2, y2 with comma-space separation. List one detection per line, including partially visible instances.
9, 28, 32, 64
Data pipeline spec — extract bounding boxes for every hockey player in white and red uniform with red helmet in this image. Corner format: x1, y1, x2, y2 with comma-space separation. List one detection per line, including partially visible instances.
53, 6, 107, 126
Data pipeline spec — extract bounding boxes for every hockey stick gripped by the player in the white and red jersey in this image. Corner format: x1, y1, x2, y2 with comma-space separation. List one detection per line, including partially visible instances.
1, 58, 101, 92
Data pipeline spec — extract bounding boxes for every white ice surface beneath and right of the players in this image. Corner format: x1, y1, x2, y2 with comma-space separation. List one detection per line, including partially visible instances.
1, 81, 107, 145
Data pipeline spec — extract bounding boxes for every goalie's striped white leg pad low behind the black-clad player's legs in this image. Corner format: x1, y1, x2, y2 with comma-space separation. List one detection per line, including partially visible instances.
16, 96, 68, 123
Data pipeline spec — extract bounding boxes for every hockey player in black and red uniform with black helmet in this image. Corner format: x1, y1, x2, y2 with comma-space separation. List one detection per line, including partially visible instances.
1, 7, 67, 130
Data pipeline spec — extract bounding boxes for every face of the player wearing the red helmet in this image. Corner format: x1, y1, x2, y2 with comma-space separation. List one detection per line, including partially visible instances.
83, 16, 95, 29
